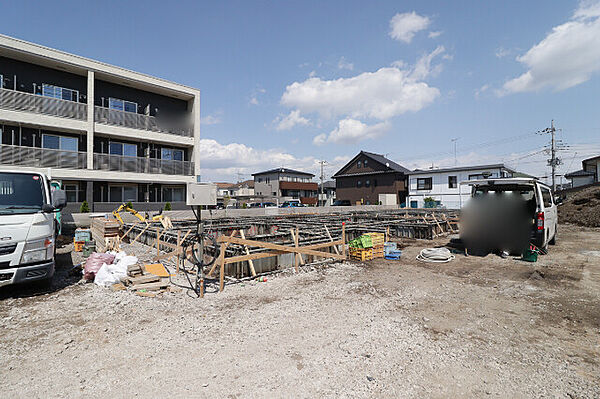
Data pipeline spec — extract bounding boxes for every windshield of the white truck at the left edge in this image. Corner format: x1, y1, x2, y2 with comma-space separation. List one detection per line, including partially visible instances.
0, 172, 45, 215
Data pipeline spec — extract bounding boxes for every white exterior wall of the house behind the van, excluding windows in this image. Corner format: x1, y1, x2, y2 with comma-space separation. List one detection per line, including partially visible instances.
406, 168, 508, 209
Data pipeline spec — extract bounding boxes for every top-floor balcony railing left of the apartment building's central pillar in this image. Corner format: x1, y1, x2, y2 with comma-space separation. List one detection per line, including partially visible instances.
0, 89, 87, 121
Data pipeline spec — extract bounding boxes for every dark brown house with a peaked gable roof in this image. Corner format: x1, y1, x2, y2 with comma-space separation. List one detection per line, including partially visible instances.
333, 151, 410, 205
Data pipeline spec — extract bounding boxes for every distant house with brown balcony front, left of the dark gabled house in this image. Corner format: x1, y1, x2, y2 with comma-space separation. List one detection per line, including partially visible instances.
252, 168, 318, 205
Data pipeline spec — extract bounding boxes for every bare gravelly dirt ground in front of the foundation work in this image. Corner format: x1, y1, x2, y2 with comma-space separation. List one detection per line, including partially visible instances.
0, 225, 600, 398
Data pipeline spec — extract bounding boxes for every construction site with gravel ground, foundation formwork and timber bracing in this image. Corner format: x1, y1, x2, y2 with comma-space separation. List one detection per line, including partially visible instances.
0, 202, 600, 398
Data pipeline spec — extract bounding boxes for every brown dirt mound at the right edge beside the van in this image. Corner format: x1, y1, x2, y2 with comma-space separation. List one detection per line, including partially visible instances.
558, 186, 600, 227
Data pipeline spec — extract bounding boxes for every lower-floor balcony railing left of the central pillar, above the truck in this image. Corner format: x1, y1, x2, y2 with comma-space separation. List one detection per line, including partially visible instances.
0, 145, 87, 169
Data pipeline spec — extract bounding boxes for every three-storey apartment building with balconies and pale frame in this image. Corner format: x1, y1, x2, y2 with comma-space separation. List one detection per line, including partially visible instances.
0, 35, 200, 212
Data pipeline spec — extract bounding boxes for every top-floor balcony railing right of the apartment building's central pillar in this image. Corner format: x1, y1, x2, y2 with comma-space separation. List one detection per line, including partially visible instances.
94, 107, 194, 137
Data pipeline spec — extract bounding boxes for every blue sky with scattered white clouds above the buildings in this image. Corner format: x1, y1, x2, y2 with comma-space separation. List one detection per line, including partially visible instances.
0, 0, 600, 182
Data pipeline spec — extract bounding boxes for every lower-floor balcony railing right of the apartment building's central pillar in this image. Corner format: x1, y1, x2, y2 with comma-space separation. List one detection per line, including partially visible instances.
94, 153, 194, 176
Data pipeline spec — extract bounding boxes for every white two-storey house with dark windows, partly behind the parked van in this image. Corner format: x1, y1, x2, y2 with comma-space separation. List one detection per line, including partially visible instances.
406, 164, 515, 209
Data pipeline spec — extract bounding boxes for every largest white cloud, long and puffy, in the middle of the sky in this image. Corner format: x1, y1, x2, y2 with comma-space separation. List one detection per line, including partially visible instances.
281, 46, 444, 120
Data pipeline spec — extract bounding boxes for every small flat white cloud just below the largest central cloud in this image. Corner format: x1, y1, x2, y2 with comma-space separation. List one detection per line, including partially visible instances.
313, 119, 390, 145
